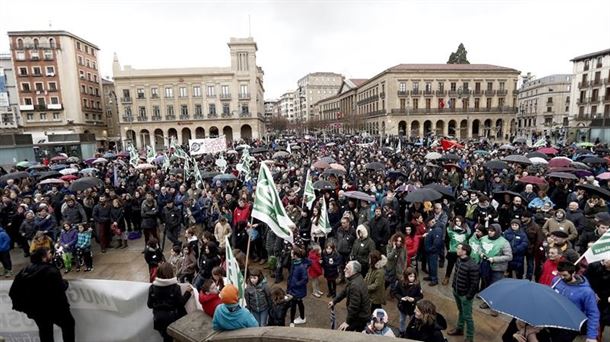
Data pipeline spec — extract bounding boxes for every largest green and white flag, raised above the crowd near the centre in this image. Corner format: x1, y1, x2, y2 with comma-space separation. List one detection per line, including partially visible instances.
252, 163, 295, 243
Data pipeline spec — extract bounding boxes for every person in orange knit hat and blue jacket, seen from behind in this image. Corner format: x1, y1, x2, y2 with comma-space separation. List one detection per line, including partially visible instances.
212, 284, 258, 331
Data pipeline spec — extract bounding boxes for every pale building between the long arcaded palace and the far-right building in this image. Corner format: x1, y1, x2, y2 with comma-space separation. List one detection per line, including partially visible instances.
517, 74, 572, 141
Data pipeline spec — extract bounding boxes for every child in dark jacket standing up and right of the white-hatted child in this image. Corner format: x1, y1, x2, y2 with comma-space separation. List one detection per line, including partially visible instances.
390, 267, 424, 335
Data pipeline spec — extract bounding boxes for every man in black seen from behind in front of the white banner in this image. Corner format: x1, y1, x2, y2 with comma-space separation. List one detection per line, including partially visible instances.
9, 247, 75, 342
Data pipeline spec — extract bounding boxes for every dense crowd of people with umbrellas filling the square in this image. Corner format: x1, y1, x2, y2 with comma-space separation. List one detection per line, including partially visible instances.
0, 136, 610, 341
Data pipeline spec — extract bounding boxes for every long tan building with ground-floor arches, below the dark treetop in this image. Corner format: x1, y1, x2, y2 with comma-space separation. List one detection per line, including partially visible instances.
317, 64, 520, 140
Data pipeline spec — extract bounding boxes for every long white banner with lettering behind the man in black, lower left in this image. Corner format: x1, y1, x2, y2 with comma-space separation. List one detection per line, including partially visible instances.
0, 279, 201, 342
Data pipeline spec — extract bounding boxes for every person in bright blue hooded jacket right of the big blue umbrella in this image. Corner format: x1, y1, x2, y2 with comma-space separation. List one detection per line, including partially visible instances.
551, 260, 600, 342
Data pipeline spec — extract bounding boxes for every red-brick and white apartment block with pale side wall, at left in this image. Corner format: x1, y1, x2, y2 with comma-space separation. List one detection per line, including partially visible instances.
8, 31, 107, 142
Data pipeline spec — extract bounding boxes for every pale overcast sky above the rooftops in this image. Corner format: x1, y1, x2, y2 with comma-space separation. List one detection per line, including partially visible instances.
0, 0, 610, 98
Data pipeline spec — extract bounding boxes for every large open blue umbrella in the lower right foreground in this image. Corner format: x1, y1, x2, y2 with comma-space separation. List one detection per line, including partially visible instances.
479, 279, 587, 331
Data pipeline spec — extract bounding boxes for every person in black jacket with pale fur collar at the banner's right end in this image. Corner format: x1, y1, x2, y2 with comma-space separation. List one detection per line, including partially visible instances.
147, 263, 193, 342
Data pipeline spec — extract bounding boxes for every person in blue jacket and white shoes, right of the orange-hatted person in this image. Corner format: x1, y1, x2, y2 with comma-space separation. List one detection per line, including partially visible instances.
287, 247, 310, 324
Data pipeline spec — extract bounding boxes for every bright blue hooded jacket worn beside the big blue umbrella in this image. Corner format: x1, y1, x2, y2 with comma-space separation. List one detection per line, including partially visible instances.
552, 274, 599, 339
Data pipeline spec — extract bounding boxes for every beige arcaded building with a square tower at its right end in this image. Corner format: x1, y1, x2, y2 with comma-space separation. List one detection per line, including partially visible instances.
113, 38, 264, 149
